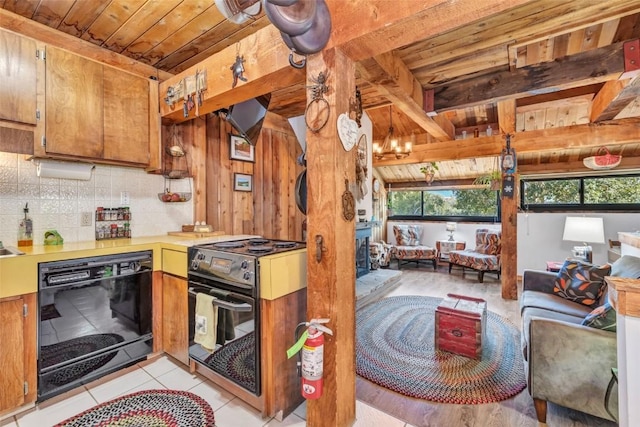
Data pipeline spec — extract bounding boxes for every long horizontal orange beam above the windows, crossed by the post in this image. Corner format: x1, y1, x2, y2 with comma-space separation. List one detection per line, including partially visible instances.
373, 122, 640, 167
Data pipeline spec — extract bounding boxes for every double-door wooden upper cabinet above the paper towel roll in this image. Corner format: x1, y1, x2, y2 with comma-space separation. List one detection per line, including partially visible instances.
44, 47, 160, 166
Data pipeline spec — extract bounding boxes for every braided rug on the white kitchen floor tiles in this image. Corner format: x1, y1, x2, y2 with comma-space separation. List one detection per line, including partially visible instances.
54, 390, 216, 427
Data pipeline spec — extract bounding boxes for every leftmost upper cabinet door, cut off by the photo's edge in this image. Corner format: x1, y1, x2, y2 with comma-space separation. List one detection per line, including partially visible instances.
0, 30, 37, 125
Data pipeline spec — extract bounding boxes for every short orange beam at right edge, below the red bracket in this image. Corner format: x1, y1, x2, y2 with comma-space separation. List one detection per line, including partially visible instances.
590, 77, 640, 123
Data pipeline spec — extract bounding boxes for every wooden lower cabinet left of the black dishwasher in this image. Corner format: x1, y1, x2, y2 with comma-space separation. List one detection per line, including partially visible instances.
0, 293, 37, 415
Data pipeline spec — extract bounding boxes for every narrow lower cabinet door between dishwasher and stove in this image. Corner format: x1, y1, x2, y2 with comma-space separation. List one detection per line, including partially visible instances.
162, 274, 189, 365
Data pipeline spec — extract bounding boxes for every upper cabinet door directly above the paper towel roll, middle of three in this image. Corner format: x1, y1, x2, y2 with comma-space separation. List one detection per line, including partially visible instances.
45, 46, 104, 159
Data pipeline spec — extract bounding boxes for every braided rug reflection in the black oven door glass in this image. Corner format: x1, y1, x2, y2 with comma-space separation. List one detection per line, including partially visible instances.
204, 332, 256, 391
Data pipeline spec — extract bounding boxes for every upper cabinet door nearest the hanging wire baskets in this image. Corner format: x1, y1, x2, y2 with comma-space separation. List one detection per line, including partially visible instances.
104, 67, 149, 165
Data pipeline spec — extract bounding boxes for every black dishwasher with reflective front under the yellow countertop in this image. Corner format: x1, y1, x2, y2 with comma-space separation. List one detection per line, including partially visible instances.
38, 251, 153, 402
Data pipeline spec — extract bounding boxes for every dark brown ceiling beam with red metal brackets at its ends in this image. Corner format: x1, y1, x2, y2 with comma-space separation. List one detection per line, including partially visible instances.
435, 43, 625, 112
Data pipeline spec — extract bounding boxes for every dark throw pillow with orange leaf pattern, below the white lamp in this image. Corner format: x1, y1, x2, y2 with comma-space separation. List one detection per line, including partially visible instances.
553, 260, 611, 308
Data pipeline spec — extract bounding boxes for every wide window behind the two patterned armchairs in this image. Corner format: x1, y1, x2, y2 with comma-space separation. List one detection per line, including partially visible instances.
389, 189, 499, 222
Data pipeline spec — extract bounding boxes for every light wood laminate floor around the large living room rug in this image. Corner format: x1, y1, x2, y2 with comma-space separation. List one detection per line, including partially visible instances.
356, 266, 617, 427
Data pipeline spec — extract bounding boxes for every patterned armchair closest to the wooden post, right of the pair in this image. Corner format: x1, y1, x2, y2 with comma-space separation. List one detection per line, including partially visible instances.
449, 228, 502, 283
